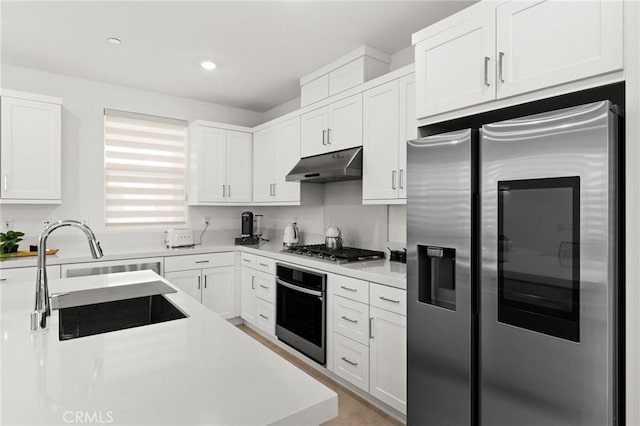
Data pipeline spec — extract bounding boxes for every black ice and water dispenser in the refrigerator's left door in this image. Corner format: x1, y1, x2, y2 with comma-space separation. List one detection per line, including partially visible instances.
418, 245, 456, 311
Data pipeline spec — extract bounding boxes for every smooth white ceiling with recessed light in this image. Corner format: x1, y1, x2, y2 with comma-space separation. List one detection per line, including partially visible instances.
0, 0, 471, 112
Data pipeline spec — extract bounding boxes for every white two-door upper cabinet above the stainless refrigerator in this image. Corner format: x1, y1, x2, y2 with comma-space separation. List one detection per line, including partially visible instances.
413, 0, 623, 118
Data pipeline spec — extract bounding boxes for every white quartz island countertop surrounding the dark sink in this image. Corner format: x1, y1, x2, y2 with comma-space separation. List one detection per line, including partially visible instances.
0, 272, 337, 425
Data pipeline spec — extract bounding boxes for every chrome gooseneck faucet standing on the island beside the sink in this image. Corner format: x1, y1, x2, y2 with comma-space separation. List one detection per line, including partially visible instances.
31, 220, 102, 331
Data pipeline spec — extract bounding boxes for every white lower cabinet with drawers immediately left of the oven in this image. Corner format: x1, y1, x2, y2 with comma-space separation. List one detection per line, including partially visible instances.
240, 253, 276, 336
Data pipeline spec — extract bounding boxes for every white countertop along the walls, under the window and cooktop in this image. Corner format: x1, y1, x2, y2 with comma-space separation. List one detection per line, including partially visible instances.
0, 236, 406, 289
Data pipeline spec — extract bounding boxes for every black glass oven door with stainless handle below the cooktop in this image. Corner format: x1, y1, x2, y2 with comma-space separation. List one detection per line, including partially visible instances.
276, 277, 326, 365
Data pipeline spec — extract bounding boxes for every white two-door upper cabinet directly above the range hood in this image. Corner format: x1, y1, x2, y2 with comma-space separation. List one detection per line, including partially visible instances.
301, 93, 362, 157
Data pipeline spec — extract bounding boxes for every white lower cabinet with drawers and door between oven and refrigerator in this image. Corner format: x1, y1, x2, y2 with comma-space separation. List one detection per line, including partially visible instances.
328, 275, 407, 414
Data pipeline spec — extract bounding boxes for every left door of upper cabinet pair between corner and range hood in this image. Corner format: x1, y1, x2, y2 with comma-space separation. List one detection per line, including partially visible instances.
253, 127, 276, 202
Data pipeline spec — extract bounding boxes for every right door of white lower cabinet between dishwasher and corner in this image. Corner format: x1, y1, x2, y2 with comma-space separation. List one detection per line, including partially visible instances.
202, 266, 236, 318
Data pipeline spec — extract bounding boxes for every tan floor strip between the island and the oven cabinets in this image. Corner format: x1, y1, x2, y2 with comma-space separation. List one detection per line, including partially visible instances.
237, 325, 403, 426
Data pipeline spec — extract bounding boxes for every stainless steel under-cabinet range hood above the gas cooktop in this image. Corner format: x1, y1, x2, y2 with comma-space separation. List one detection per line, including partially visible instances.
287, 146, 362, 183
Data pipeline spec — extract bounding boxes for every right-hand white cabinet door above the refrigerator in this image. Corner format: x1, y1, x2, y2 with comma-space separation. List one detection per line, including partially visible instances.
496, 0, 623, 98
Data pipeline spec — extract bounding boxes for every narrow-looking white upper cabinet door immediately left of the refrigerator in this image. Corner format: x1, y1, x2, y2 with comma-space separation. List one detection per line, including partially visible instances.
398, 74, 418, 199
